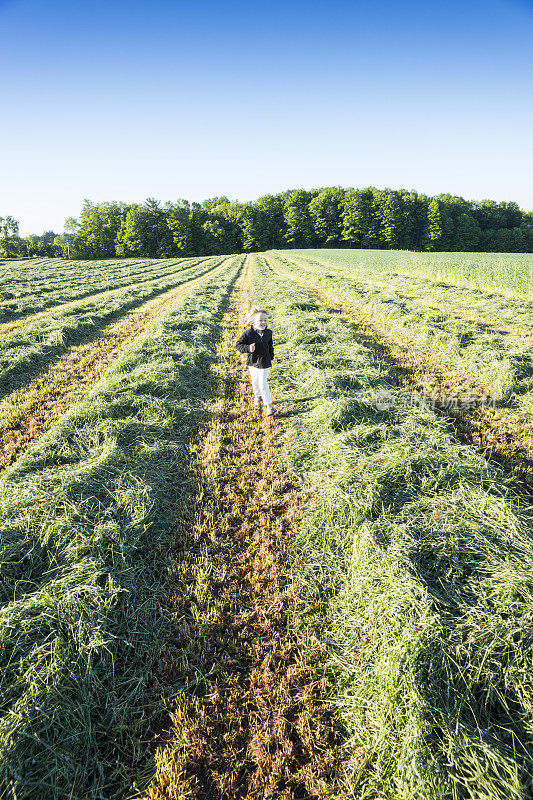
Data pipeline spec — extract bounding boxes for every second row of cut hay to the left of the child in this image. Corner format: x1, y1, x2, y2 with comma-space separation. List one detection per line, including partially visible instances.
0, 258, 224, 397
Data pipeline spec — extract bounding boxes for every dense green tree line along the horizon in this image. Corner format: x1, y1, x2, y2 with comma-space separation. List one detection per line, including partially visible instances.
0, 187, 533, 258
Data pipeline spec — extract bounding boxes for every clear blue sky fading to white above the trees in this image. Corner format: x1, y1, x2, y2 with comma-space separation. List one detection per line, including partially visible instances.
0, 0, 533, 235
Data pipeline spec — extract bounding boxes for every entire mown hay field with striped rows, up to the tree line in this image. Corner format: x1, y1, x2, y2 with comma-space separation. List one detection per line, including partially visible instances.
0, 250, 533, 800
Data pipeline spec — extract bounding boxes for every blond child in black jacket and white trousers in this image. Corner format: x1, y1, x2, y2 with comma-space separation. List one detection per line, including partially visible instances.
235, 306, 274, 417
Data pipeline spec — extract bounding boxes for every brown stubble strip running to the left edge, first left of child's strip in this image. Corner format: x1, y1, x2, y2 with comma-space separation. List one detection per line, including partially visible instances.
0, 263, 229, 470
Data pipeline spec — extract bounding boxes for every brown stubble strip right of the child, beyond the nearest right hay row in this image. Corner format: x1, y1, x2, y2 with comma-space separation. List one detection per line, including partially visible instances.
267, 258, 533, 492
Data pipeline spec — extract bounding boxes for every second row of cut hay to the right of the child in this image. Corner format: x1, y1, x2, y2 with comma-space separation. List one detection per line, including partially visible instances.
270, 254, 533, 422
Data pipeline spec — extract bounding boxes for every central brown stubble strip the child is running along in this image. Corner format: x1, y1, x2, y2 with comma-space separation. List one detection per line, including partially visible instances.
136, 258, 336, 800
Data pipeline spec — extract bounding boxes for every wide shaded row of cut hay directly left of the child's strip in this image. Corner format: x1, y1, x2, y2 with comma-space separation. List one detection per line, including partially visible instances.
0, 258, 242, 800
